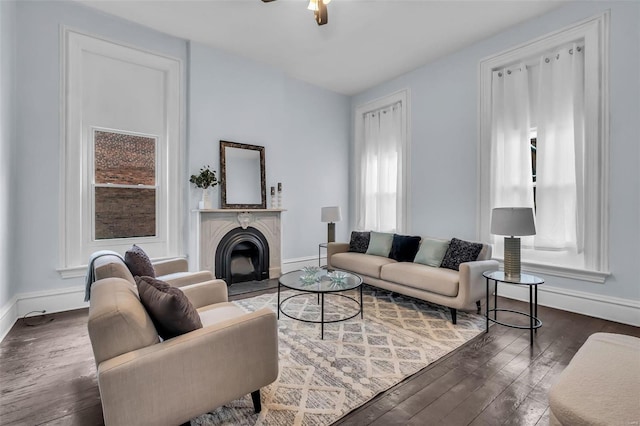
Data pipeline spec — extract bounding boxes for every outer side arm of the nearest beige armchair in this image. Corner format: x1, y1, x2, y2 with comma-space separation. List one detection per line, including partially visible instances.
98, 308, 278, 426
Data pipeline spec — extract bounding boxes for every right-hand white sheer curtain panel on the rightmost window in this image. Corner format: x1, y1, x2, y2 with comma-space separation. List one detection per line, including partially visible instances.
535, 44, 584, 252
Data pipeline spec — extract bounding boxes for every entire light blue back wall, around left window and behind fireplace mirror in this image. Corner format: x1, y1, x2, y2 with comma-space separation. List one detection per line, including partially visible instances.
8, 1, 350, 307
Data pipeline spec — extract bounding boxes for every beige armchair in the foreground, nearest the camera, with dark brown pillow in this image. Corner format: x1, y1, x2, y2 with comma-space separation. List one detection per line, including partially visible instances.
88, 256, 278, 425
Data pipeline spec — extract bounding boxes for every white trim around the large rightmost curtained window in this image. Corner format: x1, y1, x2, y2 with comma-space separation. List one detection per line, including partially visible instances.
477, 10, 610, 283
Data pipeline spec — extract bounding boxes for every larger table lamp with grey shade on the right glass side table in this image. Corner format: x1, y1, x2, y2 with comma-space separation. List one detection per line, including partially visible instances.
491, 207, 536, 280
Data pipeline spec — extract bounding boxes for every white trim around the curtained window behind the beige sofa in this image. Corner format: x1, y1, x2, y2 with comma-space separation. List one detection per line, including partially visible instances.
351, 89, 411, 233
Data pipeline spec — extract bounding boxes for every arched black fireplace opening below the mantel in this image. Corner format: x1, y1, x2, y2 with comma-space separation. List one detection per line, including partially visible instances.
215, 227, 269, 285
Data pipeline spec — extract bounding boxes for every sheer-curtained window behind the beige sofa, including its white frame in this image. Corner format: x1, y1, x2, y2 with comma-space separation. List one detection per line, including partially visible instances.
355, 91, 409, 232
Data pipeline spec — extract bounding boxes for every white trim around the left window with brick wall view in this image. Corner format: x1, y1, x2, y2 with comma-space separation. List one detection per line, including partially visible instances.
56, 26, 185, 279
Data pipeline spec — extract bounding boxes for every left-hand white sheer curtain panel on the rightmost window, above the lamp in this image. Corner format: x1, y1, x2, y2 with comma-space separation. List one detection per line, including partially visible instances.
491, 64, 533, 233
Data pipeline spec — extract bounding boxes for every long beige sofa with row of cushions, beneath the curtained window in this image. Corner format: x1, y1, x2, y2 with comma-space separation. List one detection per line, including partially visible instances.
327, 243, 498, 324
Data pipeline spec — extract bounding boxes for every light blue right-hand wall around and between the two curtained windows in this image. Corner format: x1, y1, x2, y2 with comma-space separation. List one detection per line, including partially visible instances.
352, 2, 640, 300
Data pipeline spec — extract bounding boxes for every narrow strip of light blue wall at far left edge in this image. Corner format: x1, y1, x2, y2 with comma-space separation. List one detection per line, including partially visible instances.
0, 1, 18, 306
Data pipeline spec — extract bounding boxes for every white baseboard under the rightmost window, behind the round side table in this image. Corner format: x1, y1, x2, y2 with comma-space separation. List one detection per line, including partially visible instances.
498, 283, 640, 327
